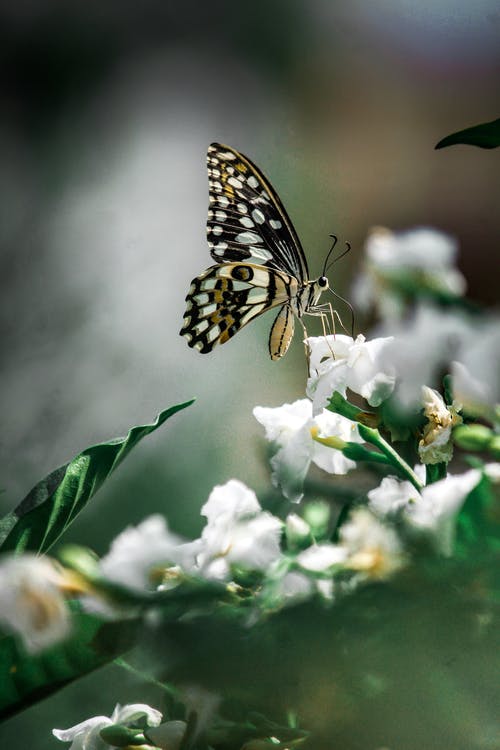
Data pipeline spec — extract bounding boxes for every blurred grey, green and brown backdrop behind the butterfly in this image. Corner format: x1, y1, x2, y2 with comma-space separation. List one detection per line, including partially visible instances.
0, 0, 500, 750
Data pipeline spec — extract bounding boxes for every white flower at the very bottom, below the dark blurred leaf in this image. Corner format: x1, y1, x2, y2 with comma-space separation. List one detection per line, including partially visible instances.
52, 703, 161, 750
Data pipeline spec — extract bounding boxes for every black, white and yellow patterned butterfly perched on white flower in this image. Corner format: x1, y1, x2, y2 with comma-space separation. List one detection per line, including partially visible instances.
180, 143, 333, 360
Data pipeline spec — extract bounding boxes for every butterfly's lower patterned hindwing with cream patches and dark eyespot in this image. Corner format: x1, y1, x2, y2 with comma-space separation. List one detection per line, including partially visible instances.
180, 263, 296, 354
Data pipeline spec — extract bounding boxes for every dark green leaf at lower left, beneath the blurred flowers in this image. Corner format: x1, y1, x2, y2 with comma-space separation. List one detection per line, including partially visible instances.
0, 612, 139, 720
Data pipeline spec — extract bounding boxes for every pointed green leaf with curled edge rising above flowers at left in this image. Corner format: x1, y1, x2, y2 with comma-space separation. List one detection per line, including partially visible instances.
0, 400, 193, 552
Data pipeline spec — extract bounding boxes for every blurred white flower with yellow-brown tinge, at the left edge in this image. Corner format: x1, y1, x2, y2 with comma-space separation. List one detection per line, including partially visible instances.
0, 554, 71, 653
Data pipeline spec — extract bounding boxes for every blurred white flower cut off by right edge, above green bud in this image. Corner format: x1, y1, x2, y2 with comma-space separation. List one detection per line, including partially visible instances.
451, 318, 500, 416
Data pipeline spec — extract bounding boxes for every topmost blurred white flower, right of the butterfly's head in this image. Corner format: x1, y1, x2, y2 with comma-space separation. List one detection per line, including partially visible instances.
354, 227, 466, 319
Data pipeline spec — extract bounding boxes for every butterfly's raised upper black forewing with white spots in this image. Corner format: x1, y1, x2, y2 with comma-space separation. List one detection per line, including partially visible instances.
207, 143, 308, 283
